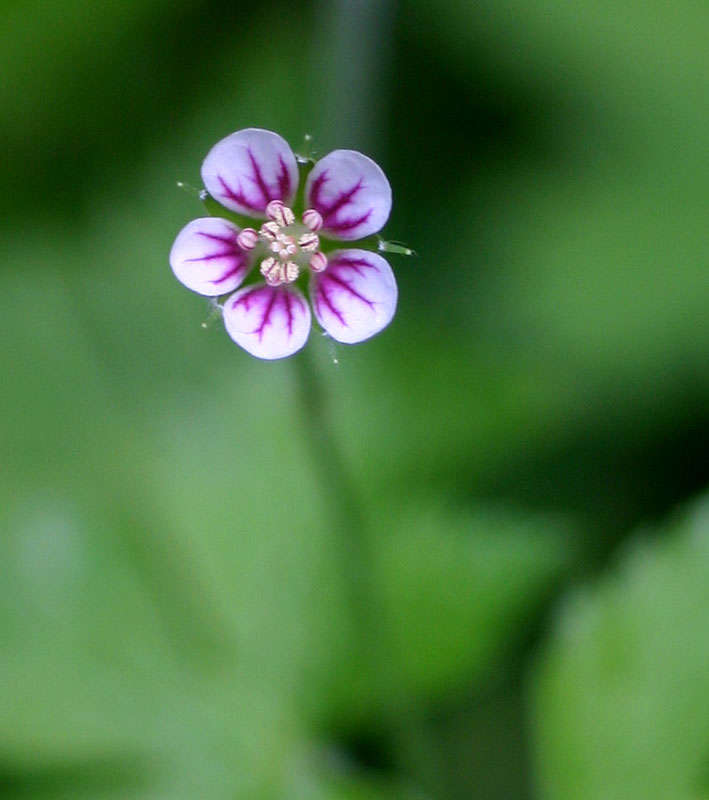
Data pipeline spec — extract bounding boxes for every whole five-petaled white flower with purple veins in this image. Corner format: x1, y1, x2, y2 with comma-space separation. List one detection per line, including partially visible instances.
170, 128, 397, 359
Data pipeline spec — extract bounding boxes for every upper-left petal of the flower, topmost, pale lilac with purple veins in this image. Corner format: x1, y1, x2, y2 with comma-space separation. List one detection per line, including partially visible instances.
202, 128, 298, 216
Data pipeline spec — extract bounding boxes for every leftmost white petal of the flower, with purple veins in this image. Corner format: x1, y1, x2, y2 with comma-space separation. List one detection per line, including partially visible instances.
170, 217, 251, 297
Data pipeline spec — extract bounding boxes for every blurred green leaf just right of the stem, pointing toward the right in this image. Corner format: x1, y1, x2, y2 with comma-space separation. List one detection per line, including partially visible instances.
322, 498, 574, 716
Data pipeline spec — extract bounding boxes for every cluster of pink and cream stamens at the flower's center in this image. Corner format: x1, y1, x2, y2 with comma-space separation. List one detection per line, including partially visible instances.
237, 200, 327, 286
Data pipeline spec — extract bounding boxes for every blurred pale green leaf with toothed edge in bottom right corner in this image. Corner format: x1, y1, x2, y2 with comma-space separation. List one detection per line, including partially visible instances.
532, 501, 709, 800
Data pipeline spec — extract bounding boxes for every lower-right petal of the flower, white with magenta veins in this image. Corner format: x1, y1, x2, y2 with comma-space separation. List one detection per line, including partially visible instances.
310, 250, 398, 344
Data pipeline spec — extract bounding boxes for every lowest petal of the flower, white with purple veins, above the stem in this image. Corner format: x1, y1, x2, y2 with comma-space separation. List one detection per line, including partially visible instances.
224, 284, 310, 359
